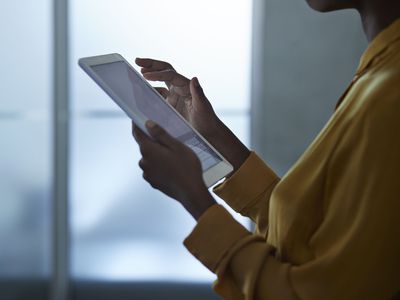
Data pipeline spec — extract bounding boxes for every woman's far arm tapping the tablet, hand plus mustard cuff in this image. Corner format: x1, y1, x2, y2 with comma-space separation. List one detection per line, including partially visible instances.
136, 58, 279, 235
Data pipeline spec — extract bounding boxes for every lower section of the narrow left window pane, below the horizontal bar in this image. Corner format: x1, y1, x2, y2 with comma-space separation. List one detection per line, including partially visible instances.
0, 119, 51, 278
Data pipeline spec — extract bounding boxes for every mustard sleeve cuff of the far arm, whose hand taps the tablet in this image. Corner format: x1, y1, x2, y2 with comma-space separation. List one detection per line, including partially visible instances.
214, 152, 279, 236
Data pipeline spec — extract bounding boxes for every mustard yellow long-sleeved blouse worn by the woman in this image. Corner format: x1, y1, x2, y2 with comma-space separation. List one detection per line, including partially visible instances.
184, 20, 400, 300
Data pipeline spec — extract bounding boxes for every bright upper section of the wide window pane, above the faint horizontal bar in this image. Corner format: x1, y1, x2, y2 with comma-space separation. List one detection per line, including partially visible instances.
71, 0, 251, 110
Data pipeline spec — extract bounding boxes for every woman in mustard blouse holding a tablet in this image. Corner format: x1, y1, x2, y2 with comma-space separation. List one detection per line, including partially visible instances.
133, 0, 400, 300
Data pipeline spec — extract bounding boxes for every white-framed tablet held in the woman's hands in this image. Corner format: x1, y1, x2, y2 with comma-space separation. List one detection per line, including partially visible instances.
79, 53, 233, 187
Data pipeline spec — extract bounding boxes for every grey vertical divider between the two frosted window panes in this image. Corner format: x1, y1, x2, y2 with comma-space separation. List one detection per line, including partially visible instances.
50, 0, 70, 300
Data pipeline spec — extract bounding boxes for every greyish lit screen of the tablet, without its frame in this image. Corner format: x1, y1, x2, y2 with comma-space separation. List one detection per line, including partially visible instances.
91, 61, 221, 172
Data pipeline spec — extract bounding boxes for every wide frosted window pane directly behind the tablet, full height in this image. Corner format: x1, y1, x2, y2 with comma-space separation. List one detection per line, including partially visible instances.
70, 0, 251, 281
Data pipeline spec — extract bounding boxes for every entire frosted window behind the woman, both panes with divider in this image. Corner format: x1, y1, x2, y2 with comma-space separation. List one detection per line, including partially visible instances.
0, 0, 251, 300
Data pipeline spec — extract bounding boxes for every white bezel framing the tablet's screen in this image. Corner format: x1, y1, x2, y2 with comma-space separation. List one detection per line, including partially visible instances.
78, 53, 233, 187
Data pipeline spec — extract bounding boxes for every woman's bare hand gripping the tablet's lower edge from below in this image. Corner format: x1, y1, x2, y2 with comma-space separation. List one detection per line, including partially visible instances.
132, 121, 216, 220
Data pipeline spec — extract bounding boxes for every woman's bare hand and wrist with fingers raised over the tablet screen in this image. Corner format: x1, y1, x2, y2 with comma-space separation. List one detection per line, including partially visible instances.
135, 58, 250, 170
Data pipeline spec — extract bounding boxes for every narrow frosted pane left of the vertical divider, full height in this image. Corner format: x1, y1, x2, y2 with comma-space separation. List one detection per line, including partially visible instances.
0, 0, 52, 284
